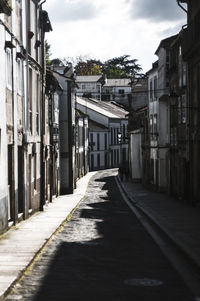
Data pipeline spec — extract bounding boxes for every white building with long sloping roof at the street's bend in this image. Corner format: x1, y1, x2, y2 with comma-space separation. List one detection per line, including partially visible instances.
77, 97, 128, 170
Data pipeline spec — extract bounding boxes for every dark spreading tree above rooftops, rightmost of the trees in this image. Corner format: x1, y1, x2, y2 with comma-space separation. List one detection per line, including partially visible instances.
103, 54, 142, 78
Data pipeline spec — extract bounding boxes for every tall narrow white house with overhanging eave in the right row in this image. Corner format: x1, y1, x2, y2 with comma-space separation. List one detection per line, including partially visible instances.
154, 35, 177, 191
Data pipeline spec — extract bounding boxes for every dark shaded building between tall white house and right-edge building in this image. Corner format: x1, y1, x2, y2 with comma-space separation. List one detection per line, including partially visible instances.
169, 29, 189, 200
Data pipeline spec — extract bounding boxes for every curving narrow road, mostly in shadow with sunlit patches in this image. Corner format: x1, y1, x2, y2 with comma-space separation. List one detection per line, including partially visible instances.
6, 170, 194, 301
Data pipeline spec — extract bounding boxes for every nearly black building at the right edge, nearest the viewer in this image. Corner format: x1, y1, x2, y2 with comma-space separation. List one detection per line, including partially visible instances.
178, 0, 200, 203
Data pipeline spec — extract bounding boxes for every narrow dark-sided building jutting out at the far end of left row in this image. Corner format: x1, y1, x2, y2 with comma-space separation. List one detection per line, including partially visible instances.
53, 66, 76, 194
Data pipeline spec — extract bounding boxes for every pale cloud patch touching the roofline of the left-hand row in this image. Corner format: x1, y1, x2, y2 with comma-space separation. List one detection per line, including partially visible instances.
45, 0, 98, 23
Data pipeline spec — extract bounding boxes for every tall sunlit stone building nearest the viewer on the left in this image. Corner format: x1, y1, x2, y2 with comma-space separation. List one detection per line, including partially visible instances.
0, 0, 52, 232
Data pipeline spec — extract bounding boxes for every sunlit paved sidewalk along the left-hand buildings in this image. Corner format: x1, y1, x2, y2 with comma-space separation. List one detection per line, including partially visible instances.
0, 172, 95, 300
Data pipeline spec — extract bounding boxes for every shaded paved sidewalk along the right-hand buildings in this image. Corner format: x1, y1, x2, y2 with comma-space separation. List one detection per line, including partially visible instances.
118, 172, 200, 269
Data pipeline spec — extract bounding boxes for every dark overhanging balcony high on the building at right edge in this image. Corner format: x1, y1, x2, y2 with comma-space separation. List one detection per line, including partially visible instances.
183, 11, 200, 60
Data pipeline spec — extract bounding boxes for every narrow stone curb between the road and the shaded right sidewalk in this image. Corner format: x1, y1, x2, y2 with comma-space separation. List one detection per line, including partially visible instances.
116, 175, 200, 272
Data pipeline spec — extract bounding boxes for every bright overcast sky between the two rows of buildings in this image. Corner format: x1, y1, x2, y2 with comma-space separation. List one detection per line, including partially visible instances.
43, 0, 186, 72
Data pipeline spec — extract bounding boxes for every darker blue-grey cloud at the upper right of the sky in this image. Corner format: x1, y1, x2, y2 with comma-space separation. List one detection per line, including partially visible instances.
127, 0, 186, 23
